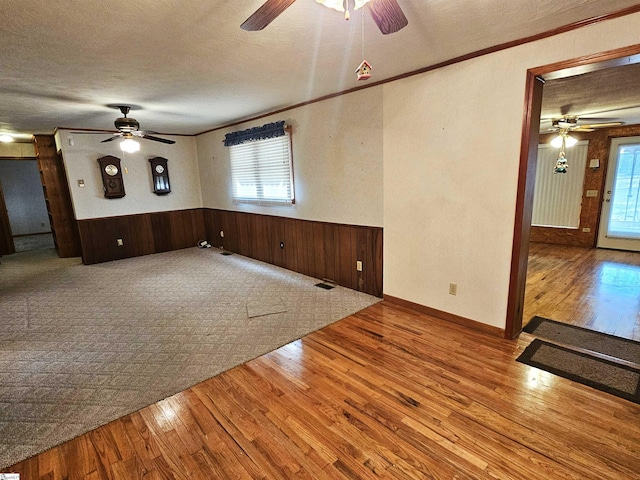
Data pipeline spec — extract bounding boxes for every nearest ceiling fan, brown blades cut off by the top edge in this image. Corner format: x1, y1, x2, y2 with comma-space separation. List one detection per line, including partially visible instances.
240, 0, 409, 35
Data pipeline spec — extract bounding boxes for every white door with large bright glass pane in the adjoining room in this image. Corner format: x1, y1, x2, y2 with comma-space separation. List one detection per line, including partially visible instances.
598, 137, 640, 252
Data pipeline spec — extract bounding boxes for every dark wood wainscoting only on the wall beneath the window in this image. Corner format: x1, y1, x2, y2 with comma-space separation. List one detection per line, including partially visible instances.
204, 209, 383, 297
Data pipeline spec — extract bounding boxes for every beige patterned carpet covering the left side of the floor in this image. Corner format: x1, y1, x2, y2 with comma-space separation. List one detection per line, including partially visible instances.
0, 247, 380, 468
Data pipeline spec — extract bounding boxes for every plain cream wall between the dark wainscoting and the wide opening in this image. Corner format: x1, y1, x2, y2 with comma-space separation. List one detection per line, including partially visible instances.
383, 14, 640, 328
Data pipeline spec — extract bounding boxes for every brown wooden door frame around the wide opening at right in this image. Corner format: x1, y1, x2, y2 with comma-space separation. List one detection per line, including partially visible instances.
504, 44, 640, 339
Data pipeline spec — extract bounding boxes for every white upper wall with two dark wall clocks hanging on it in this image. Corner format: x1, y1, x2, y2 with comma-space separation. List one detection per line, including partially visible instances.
56, 130, 202, 220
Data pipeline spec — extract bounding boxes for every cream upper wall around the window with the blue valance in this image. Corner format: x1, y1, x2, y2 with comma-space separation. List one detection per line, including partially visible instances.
197, 87, 383, 226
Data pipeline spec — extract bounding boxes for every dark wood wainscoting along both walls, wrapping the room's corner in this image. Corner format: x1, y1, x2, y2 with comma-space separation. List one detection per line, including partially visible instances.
78, 208, 383, 297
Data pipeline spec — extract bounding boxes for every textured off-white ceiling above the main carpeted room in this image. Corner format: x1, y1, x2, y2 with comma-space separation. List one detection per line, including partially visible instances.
0, 0, 638, 140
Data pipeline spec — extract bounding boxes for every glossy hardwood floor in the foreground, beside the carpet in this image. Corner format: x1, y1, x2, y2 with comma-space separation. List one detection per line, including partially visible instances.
6, 302, 640, 480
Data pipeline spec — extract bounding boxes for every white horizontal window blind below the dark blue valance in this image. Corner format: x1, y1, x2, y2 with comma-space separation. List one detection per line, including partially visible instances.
229, 130, 295, 205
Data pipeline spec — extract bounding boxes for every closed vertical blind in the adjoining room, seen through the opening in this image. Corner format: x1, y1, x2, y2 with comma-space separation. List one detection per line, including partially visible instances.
531, 141, 589, 228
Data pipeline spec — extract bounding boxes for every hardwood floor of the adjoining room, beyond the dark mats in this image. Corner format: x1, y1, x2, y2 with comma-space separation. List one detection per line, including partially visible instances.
523, 243, 640, 341
